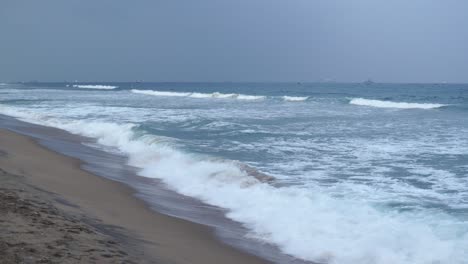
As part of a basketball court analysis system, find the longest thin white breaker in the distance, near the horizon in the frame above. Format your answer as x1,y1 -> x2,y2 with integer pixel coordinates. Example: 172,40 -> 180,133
131,89 -> 266,100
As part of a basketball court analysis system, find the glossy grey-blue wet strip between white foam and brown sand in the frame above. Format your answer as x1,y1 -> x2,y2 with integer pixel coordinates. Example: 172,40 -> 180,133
0,115 -> 300,264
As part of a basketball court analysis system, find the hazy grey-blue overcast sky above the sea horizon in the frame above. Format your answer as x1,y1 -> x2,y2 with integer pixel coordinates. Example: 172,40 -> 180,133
0,0 -> 468,83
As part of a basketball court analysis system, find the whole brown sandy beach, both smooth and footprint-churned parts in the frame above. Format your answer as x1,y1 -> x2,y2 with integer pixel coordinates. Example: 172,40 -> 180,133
0,130 -> 265,263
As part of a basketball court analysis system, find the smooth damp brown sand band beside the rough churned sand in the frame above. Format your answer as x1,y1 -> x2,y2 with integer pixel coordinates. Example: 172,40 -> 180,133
0,129 -> 267,263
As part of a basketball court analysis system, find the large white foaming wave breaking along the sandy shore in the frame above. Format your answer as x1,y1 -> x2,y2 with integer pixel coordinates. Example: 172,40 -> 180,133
0,107 -> 468,264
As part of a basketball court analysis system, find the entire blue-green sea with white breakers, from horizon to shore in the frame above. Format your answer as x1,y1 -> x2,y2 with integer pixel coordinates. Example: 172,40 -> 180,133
0,83 -> 468,264
